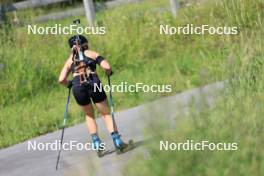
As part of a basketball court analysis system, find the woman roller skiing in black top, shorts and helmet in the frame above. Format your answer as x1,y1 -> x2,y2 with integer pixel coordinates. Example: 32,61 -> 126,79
59,35 -> 128,157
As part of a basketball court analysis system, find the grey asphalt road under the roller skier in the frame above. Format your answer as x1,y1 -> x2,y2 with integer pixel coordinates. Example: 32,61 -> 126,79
0,82 -> 224,176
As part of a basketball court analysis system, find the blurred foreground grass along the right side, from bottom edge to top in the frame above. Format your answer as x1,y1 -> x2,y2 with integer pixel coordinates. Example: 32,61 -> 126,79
124,0 -> 264,176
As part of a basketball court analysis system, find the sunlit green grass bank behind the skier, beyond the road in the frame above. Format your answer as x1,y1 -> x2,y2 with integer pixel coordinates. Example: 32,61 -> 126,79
0,0 -> 261,148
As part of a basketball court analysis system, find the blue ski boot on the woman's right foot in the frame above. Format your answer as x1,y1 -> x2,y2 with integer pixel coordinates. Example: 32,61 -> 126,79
111,132 -> 133,154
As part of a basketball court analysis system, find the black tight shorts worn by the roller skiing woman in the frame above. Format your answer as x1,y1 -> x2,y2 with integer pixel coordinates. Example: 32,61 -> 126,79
72,75 -> 107,106
